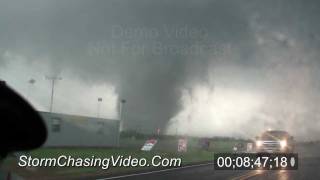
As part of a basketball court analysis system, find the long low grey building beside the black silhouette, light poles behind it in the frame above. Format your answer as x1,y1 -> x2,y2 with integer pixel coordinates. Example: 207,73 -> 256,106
39,112 -> 119,147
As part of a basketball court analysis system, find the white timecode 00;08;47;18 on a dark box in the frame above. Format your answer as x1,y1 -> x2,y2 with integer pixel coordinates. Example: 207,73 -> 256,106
214,153 -> 298,170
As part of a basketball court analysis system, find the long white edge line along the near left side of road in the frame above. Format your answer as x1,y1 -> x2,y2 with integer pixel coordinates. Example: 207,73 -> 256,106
96,163 -> 213,180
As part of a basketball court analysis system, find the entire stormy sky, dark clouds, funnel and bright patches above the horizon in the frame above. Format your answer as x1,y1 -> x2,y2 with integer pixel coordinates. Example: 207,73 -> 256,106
0,0 -> 320,139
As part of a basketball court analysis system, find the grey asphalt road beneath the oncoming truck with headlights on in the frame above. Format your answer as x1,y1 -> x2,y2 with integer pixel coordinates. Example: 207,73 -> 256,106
91,144 -> 320,180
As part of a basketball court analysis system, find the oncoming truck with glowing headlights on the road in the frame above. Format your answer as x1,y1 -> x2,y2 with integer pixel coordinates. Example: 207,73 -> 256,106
255,130 -> 294,153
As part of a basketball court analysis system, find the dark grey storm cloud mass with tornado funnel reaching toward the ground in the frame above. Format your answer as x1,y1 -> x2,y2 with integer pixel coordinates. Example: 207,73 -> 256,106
0,0 -> 320,138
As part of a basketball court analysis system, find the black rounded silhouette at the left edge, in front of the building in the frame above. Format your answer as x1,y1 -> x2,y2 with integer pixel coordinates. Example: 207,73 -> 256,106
0,80 -> 47,157
